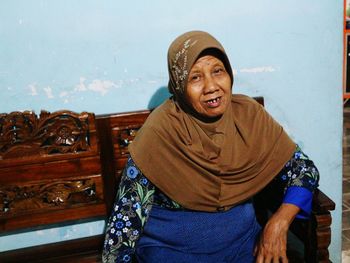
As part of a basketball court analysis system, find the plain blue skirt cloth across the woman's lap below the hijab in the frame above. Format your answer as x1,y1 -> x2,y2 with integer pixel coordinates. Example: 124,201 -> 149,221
136,202 -> 261,263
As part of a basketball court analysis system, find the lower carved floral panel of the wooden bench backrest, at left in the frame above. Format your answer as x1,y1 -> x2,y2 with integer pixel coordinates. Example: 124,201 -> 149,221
0,179 -> 97,214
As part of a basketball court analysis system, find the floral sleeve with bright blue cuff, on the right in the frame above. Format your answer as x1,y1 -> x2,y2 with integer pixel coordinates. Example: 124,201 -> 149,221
278,147 -> 319,218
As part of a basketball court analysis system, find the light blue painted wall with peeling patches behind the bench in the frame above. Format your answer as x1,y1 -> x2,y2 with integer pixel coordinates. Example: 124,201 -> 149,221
0,0 -> 343,262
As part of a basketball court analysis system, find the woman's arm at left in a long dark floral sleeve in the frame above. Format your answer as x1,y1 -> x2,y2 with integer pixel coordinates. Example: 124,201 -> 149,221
102,158 -> 155,263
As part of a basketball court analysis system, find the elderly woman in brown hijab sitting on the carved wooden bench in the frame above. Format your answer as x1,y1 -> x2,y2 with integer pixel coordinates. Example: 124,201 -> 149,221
103,31 -> 319,263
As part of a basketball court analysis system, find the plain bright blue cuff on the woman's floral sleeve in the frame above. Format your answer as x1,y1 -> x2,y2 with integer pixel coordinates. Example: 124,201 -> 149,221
283,186 -> 312,219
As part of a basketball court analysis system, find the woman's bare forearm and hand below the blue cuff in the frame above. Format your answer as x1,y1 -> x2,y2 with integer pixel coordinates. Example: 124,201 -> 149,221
254,204 -> 300,263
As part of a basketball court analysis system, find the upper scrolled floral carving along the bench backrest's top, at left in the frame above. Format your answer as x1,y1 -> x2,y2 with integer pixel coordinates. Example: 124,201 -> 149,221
0,111 -> 90,159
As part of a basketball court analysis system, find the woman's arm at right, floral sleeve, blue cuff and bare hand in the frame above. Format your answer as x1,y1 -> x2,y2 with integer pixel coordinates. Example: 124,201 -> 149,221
255,147 -> 319,263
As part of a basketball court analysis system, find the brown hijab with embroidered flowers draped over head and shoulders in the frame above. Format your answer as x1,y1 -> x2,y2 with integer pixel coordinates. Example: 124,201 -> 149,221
129,31 -> 295,211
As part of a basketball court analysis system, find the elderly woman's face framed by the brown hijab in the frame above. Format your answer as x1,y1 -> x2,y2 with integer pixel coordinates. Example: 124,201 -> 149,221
185,55 -> 231,118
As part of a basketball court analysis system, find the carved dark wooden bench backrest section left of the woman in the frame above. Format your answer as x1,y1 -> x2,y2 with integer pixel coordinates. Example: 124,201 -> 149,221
0,111 -> 106,231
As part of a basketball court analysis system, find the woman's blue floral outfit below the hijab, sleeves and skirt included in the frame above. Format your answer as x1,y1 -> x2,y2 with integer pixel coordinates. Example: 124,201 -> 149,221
102,147 -> 319,263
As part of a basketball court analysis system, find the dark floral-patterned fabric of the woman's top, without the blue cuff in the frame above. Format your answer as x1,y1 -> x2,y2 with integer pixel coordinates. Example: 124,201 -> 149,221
102,147 -> 319,263
